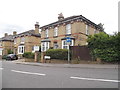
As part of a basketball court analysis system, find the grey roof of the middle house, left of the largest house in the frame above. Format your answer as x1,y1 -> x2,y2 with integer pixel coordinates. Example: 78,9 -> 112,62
14,30 -> 40,38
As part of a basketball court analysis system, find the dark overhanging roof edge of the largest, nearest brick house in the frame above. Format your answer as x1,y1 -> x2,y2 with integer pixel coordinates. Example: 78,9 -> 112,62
40,15 -> 104,30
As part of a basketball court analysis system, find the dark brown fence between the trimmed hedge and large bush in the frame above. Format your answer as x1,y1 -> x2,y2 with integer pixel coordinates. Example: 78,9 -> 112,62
70,46 -> 92,60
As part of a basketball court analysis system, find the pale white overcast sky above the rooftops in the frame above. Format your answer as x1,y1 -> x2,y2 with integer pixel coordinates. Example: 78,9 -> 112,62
0,0 -> 119,37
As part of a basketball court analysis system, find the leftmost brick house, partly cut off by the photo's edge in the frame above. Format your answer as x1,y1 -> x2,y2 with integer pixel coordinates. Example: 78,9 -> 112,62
0,31 -> 16,56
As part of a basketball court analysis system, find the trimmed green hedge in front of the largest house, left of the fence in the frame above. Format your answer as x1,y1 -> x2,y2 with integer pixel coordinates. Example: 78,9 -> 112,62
46,49 -> 68,60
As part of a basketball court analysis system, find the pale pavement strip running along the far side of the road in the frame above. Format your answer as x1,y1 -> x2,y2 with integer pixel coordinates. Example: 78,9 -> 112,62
12,59 -> 119,69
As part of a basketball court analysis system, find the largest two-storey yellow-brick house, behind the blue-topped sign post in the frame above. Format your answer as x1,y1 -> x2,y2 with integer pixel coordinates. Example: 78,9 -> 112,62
40,13 -> 103,52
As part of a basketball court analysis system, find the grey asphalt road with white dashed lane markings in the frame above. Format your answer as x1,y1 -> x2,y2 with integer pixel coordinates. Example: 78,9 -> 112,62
0,61 -> 119,88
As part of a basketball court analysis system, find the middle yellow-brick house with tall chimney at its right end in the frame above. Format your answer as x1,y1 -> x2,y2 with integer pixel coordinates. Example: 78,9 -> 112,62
14,22 -> 41,56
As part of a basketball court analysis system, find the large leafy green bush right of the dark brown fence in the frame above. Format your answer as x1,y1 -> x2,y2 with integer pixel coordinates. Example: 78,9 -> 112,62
87,32 -> 120,61
